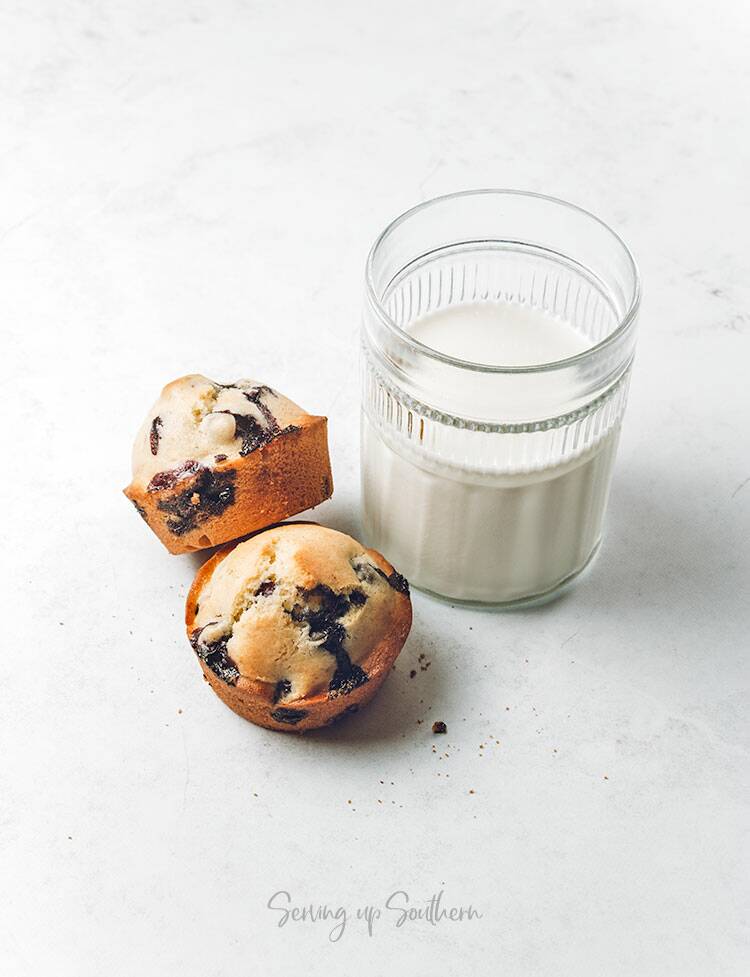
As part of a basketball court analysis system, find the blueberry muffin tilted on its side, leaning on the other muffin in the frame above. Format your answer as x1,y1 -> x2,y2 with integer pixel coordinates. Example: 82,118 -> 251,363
125,374 -> 333,553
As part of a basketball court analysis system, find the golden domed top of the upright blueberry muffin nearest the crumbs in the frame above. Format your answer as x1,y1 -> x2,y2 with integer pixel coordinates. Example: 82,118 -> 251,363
191,523 -> 408,703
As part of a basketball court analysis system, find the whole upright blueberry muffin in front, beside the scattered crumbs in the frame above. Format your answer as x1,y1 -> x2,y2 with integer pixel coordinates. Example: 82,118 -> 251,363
186,523 -> 411,732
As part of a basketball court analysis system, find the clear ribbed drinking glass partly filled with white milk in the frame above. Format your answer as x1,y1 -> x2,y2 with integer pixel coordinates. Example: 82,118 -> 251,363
362,190 -> 639,606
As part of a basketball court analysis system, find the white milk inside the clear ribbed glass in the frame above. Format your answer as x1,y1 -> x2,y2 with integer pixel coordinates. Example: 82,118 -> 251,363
362,302 -> 619,603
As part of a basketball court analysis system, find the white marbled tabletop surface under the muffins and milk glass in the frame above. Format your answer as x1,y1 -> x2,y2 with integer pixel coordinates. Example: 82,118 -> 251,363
0,0 -> 750,977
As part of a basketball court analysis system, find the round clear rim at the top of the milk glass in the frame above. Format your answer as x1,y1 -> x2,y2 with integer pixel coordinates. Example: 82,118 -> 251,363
365,187 -> 641,374
